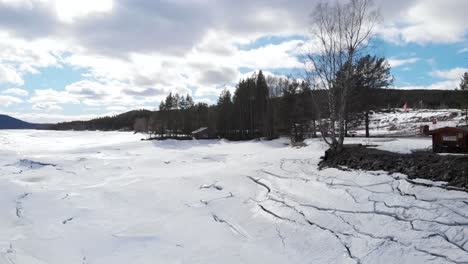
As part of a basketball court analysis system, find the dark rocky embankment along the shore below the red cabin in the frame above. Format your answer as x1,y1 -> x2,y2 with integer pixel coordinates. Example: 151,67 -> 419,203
320,145 -> 468,191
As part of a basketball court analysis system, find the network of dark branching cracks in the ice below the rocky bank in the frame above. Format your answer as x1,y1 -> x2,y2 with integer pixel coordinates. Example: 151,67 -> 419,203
250,159 -> 468,263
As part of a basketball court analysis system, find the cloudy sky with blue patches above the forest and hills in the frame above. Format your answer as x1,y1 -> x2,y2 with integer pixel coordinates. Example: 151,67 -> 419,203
0,0 -> 468,122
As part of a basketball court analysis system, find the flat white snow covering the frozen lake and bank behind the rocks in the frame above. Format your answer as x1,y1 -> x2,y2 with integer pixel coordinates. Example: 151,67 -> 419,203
0,131 -> 468,264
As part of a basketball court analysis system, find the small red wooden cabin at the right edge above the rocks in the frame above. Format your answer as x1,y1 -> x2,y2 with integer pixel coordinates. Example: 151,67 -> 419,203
427,127 -> 468,153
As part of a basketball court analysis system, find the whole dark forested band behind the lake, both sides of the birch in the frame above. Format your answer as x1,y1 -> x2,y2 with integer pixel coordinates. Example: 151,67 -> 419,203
47,74 -> 468,141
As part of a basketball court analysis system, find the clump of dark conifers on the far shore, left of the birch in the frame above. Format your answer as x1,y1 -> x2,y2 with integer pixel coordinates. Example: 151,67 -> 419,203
148,71 -> 315,140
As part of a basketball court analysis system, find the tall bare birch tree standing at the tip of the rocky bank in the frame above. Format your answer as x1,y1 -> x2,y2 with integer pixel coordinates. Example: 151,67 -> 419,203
306,0 -> 380,152
